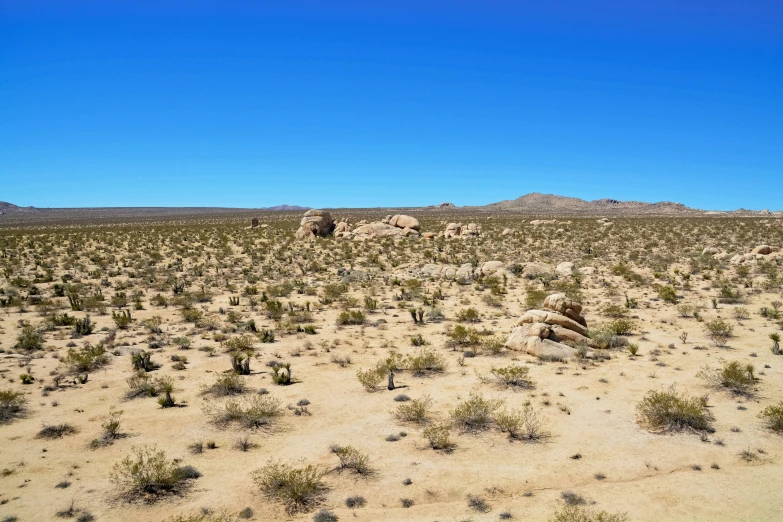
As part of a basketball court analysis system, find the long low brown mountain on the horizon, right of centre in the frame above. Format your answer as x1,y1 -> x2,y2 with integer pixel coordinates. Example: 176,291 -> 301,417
481,192 -> 704,214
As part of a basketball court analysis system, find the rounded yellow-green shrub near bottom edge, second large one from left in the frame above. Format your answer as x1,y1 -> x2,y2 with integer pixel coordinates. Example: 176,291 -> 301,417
252,462 -> 327,514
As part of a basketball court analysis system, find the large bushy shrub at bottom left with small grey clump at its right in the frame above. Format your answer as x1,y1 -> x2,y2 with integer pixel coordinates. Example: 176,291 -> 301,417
110,446 -> 198,499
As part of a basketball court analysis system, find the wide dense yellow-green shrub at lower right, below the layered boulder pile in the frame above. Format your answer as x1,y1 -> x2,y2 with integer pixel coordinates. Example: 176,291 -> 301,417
636,387 -> 715,433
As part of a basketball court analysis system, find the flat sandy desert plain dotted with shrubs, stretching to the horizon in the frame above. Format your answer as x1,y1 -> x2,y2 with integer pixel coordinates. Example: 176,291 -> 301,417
0,208 -> 783,522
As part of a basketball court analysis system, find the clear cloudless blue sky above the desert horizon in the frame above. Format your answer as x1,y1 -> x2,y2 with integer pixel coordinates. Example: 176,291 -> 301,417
0,0 -> 783,210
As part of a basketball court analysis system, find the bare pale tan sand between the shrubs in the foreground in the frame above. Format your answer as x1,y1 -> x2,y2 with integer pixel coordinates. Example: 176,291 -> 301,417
0,213 -> 783,521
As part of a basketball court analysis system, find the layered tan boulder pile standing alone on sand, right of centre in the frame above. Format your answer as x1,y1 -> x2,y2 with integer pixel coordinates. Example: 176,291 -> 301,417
506,294 -> 596,360
